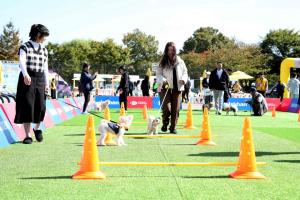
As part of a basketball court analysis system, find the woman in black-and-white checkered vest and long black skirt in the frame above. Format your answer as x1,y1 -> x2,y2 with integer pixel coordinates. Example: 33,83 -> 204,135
14,24 -> 49,144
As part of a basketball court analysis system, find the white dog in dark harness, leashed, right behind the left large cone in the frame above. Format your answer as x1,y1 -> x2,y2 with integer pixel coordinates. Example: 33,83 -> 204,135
97,115 -> 133,146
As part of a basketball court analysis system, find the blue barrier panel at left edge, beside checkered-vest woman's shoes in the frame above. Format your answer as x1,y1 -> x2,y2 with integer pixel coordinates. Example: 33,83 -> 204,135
0,109 -> 19,148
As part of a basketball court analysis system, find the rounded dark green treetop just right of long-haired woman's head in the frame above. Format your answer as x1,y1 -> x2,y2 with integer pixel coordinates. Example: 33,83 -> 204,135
181,27 -> 233,53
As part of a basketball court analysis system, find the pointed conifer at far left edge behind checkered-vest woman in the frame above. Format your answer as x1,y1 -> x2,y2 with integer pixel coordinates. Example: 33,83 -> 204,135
0,22 -> 21,60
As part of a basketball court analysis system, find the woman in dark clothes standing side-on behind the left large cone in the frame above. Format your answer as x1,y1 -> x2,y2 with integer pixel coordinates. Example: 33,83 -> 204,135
80,63 -> 97,114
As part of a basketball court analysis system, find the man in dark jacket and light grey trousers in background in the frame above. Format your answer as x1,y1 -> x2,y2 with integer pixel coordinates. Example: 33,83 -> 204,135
208,61 -> 229,115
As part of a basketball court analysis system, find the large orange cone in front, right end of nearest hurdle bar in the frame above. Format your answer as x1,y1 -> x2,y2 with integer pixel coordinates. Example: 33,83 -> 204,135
230,117 -> 265,179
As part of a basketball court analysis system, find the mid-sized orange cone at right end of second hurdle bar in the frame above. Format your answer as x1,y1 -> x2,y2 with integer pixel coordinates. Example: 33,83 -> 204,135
196,108 -> 216,146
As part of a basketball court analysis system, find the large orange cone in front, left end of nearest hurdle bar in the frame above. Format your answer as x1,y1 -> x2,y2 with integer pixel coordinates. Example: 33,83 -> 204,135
72,116 -> 106,179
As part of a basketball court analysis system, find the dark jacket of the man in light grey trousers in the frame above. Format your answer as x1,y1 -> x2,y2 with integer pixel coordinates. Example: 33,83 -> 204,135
208,69 -> 229,90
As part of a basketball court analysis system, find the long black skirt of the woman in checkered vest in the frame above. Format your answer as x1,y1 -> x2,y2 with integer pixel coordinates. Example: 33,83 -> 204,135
14,71 -> 46,124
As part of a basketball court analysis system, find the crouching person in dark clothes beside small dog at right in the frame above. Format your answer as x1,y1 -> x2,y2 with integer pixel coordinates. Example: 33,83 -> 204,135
246,87 -> 268,116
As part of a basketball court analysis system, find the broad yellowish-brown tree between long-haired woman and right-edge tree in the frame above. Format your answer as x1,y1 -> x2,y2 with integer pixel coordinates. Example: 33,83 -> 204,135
181,43 -> 270,83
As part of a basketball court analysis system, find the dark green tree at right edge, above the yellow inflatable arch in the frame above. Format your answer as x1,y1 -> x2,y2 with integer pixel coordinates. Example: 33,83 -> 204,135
260,29 -> 300,74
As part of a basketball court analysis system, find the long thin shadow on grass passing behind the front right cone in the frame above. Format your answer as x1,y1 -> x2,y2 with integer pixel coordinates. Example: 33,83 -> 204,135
188,151 -> 300,157
